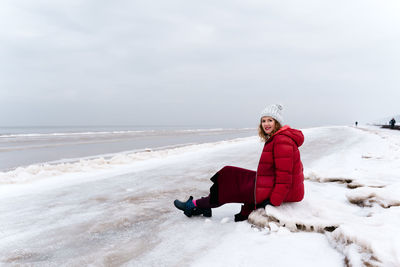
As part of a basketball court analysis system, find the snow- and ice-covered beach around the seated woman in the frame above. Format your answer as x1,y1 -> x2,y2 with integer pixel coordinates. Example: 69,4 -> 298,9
0,126 -> 400,266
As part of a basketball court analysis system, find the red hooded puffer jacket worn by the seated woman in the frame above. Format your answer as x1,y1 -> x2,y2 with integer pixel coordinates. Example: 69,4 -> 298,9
254,126 -> 304,206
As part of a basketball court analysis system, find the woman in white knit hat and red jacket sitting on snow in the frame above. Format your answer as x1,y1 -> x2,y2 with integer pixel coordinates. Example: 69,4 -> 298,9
174,104 -> 304,221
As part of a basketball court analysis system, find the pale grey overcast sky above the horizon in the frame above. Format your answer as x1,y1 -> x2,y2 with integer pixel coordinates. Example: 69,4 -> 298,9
0,0 -> 400,130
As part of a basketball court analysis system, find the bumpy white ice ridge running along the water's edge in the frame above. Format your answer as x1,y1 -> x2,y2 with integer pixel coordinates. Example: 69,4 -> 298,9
0,136 -> 257,193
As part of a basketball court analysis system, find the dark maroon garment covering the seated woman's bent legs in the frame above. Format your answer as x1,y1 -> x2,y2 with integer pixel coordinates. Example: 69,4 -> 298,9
196,166 -> 256,215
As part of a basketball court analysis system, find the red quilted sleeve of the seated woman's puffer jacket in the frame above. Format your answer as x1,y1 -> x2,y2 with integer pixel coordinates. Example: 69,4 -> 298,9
270,136 -> 295,206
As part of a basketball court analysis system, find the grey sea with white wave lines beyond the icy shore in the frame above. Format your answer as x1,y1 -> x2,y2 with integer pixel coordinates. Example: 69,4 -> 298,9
0,126 -> 257,172
